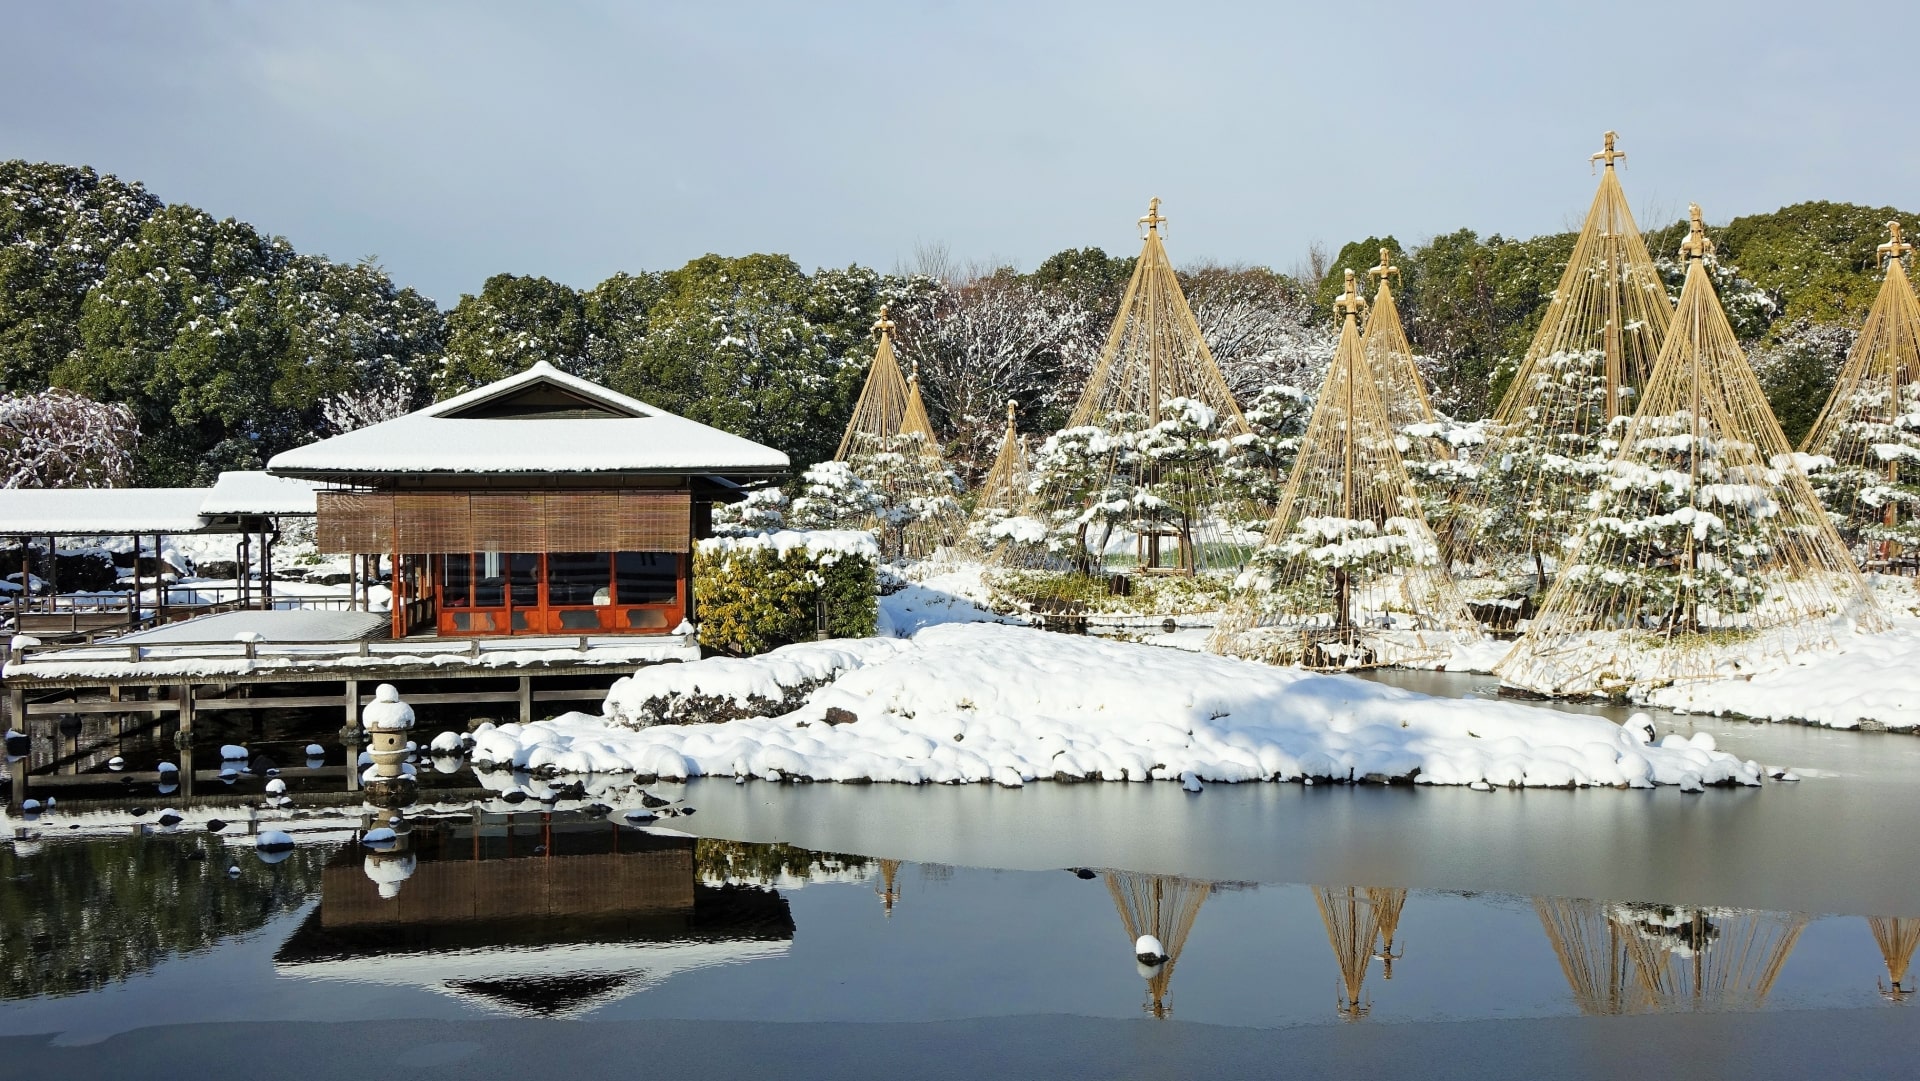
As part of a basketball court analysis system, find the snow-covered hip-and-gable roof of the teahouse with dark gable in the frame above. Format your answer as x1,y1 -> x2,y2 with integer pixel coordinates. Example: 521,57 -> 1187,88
267,361 -> 789,480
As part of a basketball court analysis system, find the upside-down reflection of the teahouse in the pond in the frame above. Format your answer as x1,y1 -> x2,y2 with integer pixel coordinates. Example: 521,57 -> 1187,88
275,814 -> 793,1018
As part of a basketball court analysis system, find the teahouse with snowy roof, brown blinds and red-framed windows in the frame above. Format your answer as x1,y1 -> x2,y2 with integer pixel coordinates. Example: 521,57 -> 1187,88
267,363 -> 787,637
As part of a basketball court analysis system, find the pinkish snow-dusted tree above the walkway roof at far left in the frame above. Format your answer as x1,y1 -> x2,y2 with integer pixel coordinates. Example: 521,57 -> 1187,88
0,388 -> 140,488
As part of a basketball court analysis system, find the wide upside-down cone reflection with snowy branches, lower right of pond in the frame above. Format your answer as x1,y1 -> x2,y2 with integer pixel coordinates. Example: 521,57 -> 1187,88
1615,904 -> 1807,1010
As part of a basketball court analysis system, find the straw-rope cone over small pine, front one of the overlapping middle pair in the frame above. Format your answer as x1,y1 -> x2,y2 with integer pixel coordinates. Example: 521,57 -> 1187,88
1212,271 -> 1480,668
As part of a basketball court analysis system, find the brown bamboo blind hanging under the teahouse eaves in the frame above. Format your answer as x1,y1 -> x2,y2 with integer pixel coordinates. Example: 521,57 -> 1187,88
315,492 -> 693,553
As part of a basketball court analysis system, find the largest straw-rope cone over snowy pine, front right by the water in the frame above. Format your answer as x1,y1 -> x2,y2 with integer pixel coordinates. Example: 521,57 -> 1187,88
1494,205 -> 1889,695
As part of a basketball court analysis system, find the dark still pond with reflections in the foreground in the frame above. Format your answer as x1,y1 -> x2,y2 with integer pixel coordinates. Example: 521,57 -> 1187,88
0,674 -> 1920,1075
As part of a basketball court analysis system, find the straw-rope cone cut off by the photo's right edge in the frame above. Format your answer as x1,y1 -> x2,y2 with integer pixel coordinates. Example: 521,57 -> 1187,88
1801,221 -> 1920,563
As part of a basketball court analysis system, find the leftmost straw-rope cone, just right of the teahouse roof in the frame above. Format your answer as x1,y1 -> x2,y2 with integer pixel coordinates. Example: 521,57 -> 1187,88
833,307 -> 964,559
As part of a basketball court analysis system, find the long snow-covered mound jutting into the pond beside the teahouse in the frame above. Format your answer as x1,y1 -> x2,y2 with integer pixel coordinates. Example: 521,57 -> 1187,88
474,624 -> 1763,787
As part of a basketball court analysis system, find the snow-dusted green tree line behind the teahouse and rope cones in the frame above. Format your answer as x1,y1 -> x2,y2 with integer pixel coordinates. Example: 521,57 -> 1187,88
0,161 -> 1914,484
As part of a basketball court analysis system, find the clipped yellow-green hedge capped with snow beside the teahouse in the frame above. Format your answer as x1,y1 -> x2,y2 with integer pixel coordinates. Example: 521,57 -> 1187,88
693,534 -> 879,657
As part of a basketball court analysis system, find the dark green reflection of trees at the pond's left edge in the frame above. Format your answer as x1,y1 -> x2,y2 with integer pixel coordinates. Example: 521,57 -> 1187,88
0,833 -> 328,998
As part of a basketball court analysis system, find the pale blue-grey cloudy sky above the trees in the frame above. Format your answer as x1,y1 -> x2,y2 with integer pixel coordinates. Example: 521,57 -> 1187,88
0,0 -> 1920,305
